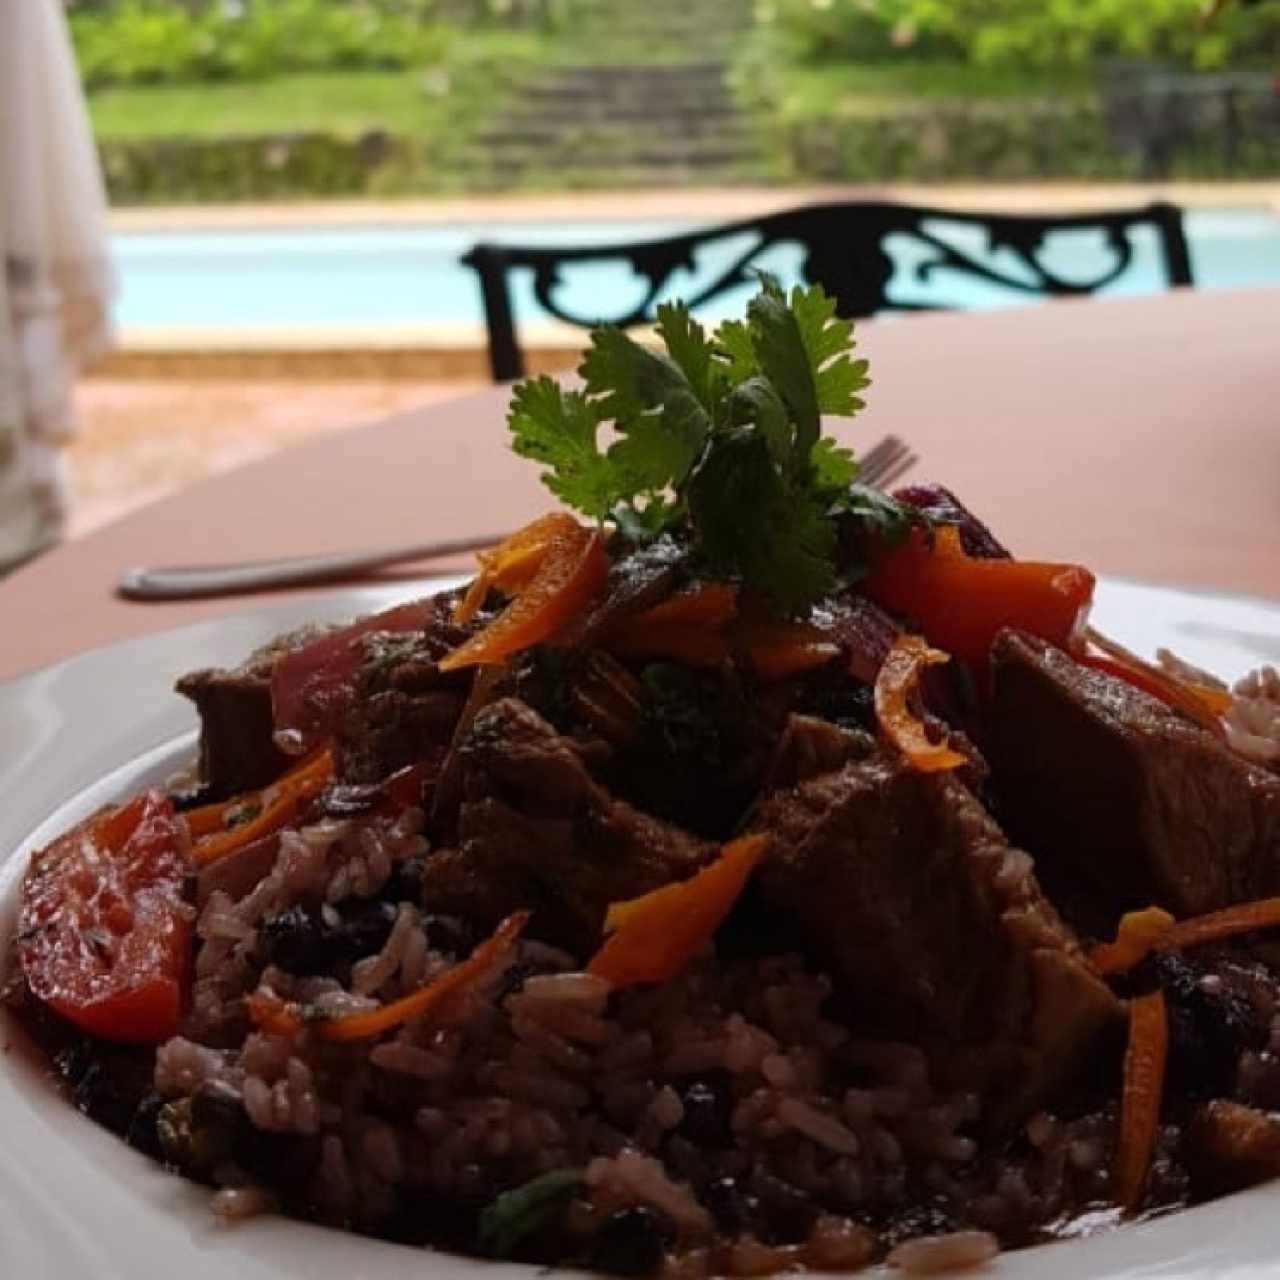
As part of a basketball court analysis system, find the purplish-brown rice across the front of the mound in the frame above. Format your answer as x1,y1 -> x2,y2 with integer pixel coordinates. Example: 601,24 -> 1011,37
140,798 -> 1141,1280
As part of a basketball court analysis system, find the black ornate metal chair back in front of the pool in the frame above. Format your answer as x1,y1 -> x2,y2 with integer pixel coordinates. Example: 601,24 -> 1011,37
462,201 -> 1193,381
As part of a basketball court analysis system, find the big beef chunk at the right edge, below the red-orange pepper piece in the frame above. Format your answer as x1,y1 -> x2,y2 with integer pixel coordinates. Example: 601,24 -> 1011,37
987,631 -> 1280,932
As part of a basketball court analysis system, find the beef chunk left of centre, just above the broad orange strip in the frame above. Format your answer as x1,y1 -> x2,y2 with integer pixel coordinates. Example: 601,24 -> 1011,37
422,698 -> 714,954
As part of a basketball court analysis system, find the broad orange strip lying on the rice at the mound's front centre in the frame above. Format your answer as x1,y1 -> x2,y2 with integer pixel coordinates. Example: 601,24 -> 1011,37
588,835 -> 769,987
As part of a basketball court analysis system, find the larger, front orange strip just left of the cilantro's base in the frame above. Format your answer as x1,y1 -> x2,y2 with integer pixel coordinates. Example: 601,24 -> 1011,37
440,524 -> 609,671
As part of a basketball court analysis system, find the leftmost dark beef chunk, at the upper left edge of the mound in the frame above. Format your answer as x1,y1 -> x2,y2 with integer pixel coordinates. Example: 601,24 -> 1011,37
177,627 -> 321,797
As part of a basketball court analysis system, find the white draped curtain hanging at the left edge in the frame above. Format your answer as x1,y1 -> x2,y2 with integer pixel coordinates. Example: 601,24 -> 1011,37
0,0 -> 114,571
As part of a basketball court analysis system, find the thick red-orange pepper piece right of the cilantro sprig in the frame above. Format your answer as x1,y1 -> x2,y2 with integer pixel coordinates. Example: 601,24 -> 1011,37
863,526 -> 1094,663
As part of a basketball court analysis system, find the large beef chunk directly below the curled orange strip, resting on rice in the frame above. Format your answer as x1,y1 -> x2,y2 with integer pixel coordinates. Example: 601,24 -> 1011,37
755,753 -> 1119,1115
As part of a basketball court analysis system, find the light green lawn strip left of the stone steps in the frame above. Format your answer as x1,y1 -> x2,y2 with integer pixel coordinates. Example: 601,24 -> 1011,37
88,32 -> 550,138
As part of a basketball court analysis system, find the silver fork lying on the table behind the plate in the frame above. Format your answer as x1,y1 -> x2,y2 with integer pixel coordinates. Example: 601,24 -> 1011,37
116,435 -> 918,600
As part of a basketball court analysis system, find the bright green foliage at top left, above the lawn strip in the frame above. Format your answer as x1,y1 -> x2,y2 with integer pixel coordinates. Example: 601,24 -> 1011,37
70,0 -> 448,88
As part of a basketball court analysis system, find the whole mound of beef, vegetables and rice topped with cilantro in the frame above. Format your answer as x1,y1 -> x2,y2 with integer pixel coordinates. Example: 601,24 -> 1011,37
9,280 -> 1280,1277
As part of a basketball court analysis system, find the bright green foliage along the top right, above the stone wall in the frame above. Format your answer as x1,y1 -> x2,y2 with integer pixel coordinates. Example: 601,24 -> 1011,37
764,0 -> 1280,68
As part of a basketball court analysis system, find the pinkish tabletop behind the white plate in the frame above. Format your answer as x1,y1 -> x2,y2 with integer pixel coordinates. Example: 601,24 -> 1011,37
0,289 -> 1280,678
